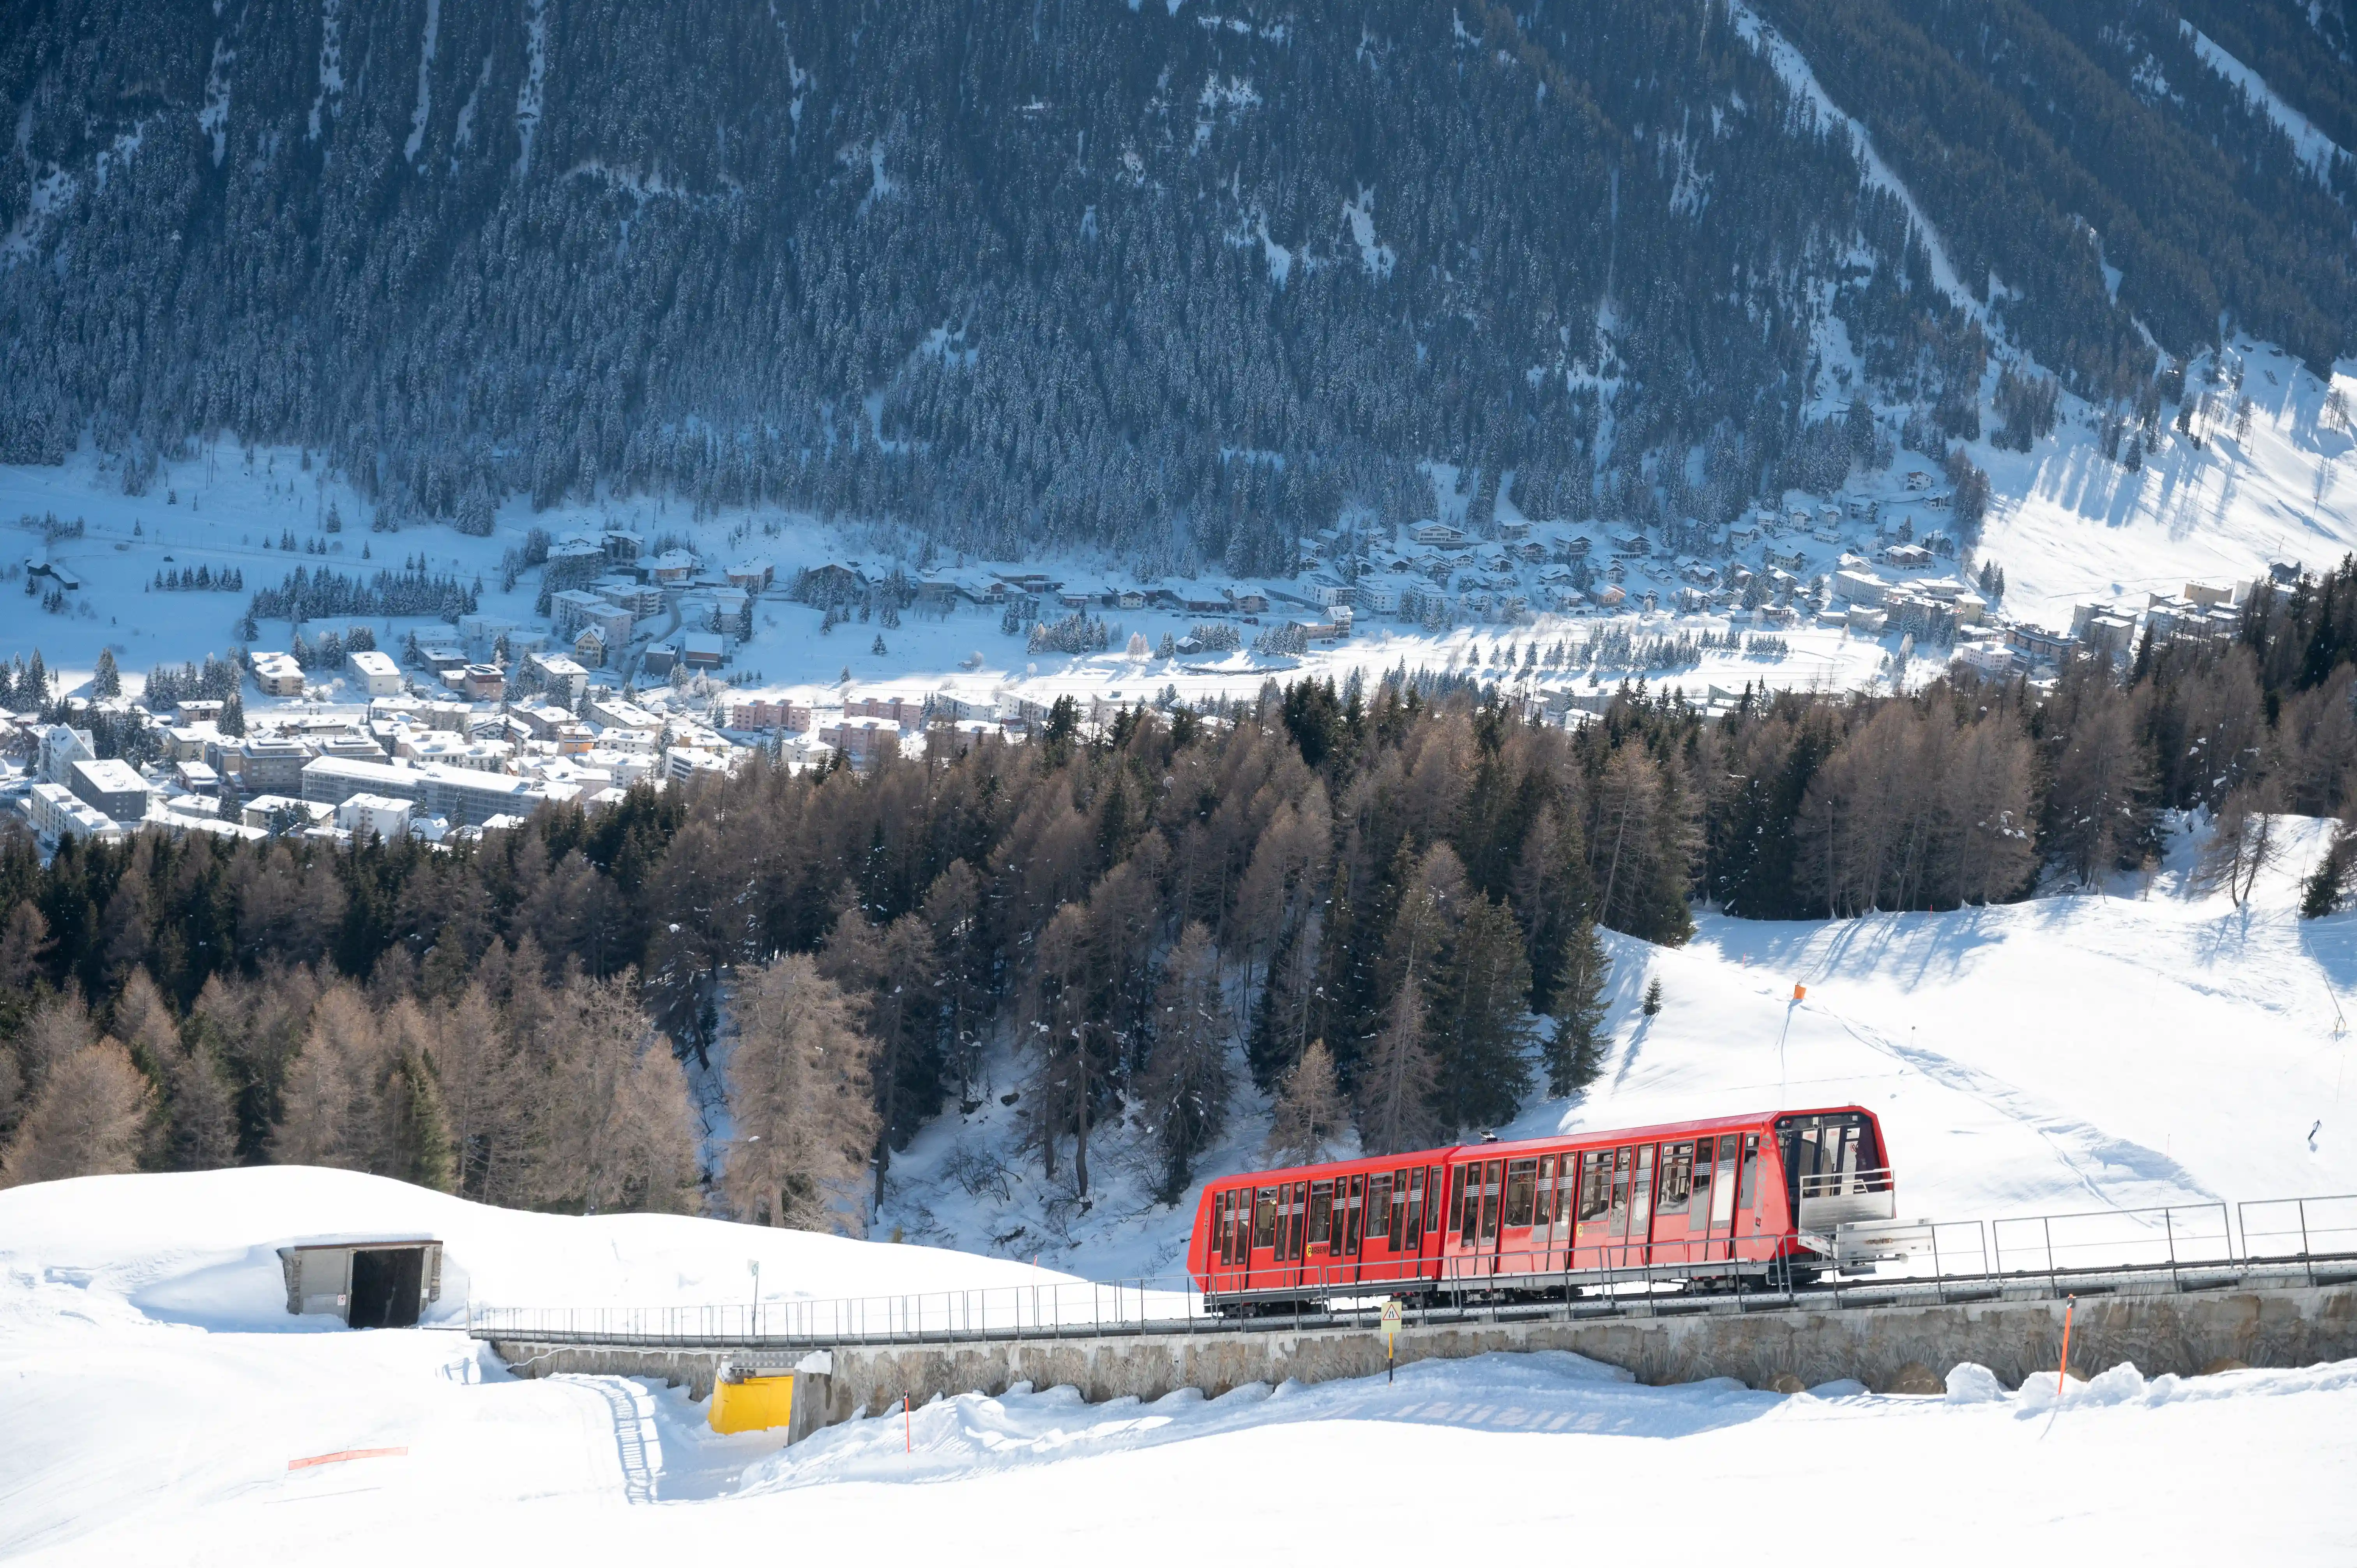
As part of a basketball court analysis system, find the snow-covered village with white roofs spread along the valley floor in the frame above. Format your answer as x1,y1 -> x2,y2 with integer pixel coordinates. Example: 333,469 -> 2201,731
0,391 -> 2329,844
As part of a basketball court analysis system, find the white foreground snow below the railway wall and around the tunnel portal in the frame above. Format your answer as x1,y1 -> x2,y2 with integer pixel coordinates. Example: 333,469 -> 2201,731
0,1169 -> 2357,1566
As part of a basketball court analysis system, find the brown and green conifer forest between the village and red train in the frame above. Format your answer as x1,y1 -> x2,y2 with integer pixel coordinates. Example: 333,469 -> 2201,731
14,561 -> 2357,1229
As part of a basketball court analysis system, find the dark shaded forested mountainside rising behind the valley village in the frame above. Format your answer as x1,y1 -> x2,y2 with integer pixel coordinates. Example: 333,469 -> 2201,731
0,0 -> 2357,570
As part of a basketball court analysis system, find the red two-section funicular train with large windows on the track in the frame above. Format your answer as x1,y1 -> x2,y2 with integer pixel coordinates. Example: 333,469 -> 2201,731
1188,1106 -> 1898,1313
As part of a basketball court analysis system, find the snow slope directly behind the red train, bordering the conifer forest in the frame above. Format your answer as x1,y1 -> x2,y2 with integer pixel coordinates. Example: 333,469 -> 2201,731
884,818 -> 2357,1278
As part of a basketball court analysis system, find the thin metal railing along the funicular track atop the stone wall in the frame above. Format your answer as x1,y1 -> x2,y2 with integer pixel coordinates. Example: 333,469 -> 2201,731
467,1195 -> 2357,1349
